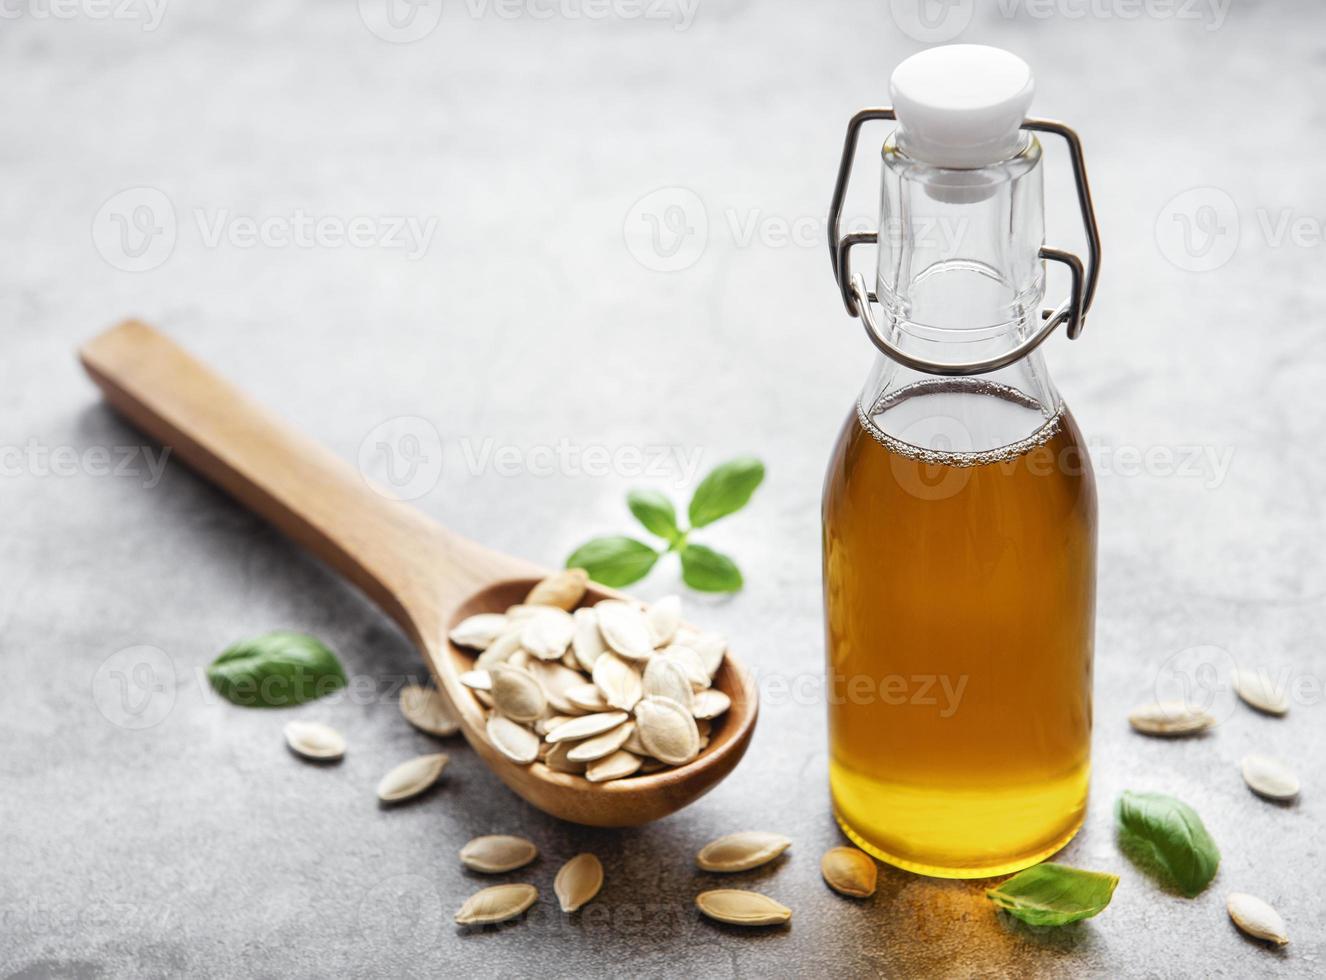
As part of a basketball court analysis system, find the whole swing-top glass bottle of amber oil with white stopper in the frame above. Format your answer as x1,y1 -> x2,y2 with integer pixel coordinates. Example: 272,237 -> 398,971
823,45 -> 1098,878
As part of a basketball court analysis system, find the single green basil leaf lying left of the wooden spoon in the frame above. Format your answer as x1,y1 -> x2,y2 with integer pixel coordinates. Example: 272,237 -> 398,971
207,630 -> 346,708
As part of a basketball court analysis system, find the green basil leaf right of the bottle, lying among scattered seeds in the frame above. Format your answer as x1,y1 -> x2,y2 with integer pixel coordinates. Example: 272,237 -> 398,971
1114,790 -> 1220,898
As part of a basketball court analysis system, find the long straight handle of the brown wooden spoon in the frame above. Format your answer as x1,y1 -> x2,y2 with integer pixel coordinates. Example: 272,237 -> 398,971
80,321 -> 480,646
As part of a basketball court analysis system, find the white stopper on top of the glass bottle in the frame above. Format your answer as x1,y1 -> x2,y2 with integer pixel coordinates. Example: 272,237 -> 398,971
888,44 -> 1036,170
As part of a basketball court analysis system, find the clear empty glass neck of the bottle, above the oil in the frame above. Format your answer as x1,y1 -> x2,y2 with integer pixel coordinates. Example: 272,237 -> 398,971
861,134 -> 1059,454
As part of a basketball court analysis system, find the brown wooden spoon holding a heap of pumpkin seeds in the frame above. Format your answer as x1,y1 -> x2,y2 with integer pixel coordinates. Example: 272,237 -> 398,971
80,321 -> 757,826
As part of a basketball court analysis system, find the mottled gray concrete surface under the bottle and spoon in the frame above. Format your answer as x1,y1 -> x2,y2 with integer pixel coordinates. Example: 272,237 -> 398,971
0,0 -> 1326,977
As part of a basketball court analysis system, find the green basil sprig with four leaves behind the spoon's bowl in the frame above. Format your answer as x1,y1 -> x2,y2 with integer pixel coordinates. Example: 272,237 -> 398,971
566,456 -> 764,591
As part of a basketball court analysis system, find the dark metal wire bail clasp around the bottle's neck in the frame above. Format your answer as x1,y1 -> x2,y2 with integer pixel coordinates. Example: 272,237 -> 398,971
829,107 -> 1101,375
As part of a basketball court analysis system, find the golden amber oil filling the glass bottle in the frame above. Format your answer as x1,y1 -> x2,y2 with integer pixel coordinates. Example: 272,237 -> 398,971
823,379 -> 1095,878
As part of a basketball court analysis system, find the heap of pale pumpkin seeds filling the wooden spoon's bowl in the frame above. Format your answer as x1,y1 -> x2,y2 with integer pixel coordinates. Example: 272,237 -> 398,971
450,569 -> 731,782
